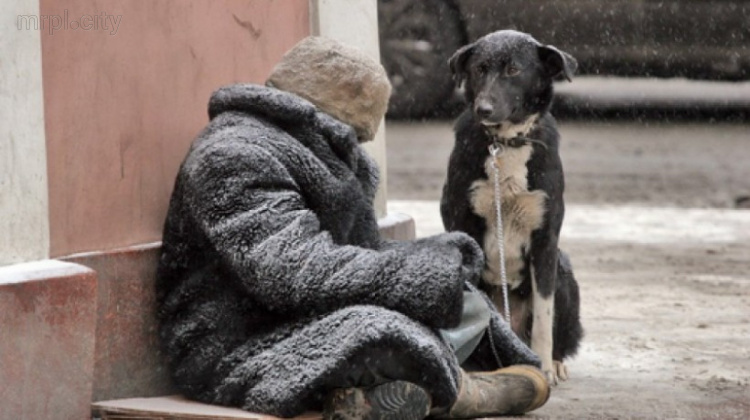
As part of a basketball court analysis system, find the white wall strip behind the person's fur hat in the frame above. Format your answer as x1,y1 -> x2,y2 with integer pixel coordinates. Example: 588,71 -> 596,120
311,0 -> 388,217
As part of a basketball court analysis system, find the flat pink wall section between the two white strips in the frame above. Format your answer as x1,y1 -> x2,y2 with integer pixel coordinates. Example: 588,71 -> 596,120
40,0 -> 310,257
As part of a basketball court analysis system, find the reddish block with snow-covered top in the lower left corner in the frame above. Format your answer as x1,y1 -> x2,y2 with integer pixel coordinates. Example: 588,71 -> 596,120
0,260 -> 97,420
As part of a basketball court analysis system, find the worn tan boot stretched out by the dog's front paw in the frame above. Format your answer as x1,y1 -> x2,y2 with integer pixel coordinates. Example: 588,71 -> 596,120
438,365 -> 550,419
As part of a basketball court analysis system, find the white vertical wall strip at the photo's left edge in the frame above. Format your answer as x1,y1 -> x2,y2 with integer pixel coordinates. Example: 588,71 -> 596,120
0,0 -> 49,266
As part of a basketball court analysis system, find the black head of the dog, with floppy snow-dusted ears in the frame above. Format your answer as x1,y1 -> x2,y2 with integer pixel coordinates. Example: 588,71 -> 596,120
448,30 -> 578,126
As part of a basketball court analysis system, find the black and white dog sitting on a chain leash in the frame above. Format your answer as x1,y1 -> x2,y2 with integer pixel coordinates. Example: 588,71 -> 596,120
440,30 -> 583,383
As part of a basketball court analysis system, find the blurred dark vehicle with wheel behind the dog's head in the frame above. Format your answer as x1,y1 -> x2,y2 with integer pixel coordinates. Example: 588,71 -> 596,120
378,0 -> 750,119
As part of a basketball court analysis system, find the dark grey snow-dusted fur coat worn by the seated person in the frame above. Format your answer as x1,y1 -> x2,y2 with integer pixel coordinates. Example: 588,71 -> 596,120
157,85 -> 538,417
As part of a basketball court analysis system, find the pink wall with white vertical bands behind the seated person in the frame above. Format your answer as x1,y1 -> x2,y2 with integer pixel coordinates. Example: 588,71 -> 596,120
0,0 -> 394,264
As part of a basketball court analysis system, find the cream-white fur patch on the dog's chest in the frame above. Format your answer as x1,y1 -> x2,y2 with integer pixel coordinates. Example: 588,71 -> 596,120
469,145 -> 546,288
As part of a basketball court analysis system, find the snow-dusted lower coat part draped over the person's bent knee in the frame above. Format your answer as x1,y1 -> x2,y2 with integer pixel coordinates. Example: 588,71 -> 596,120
209,306 -> 460,417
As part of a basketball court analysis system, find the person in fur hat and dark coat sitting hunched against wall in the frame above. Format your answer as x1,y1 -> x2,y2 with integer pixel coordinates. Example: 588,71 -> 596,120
156,37 -> 549,420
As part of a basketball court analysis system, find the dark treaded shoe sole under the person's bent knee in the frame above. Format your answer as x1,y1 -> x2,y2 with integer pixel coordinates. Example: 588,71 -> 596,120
323,381 -> 431,420
